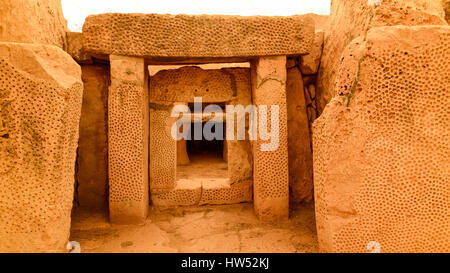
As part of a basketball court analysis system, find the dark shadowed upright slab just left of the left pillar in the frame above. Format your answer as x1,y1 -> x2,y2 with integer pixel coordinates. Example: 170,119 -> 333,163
77,65 -> 110,209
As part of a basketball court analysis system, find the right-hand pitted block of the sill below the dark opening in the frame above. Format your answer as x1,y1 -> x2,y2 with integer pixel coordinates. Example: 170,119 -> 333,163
199,179 -> 253,205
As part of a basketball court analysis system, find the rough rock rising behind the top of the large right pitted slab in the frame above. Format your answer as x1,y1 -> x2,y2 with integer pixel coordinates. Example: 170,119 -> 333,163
317,0 -> 447,113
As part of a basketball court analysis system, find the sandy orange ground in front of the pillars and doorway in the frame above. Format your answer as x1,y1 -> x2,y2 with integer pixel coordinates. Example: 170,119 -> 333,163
71,202 -> 318,253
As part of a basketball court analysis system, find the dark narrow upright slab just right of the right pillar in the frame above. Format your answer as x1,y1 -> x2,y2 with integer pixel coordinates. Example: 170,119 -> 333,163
286,60 -> 313,203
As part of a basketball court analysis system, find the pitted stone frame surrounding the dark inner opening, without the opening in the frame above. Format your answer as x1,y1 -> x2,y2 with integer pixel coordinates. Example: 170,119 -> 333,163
150,67 -> 253,206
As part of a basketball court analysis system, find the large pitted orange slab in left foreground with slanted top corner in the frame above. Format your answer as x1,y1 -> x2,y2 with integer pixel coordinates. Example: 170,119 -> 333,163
0,43 -> 83,252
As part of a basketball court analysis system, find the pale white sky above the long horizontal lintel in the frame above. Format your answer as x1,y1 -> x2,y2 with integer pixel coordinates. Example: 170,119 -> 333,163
61,0 -> 331,31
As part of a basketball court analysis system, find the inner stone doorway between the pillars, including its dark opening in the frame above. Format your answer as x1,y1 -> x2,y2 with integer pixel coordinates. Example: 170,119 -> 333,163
149,64 -> 253,206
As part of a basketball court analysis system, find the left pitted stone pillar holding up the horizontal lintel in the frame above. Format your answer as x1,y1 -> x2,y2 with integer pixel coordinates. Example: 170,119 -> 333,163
108,55 -> 149,224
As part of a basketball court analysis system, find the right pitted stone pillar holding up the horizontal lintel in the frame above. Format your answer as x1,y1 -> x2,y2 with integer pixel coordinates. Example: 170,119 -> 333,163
252,56 -> 289,221
